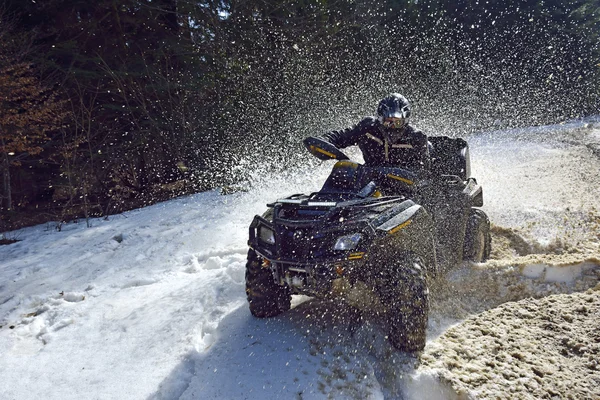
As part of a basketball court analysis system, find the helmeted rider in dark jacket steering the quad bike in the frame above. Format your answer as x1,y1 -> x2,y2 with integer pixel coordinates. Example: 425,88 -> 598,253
304,93 -> 430,172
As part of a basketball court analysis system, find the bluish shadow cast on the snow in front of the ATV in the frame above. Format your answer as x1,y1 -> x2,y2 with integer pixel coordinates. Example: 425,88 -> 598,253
150,299 -> 415,400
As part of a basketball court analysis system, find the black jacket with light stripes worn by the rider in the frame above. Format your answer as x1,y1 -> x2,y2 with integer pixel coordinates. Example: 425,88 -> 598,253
321,117 -> 430,171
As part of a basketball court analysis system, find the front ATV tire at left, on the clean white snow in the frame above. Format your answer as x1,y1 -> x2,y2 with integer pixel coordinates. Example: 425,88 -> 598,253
246,249 -> 292,318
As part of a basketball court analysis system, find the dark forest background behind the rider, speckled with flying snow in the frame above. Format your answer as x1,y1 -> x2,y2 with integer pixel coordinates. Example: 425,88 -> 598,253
0,0 -> 600,231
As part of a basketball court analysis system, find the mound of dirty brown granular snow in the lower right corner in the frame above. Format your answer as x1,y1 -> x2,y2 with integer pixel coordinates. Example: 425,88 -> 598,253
407,285 -> 600,399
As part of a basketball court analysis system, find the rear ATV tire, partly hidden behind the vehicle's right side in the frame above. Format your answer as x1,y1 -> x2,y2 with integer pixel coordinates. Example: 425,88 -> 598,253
463,208 -> 492,263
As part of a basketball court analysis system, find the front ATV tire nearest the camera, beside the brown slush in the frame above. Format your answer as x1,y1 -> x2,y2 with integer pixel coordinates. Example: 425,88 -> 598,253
376,254 -> 429,352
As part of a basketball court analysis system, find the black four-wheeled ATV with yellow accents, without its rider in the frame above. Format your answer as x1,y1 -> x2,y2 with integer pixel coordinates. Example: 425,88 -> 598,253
246,136 -> 491,351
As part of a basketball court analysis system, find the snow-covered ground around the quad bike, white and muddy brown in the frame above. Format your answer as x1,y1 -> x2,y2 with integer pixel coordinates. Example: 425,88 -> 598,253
0,121 -> 600,400
